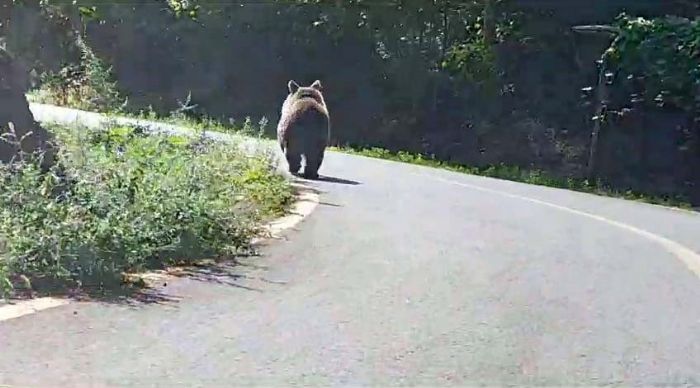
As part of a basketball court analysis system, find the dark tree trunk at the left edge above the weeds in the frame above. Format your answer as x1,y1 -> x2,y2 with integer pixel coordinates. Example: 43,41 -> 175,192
0,49 -> 55,169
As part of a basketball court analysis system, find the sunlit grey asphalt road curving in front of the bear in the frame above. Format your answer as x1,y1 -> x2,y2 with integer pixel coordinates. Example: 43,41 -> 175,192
0,123 -> 700,387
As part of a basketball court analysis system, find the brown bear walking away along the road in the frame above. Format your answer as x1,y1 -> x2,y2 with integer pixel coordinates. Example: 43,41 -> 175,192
277,80 -> 331,179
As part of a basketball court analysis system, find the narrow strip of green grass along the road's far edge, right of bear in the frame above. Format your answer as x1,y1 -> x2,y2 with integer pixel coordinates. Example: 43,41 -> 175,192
331,147 -> 691,209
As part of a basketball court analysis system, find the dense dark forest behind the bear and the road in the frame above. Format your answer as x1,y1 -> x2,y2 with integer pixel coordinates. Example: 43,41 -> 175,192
0,0 -> 700,206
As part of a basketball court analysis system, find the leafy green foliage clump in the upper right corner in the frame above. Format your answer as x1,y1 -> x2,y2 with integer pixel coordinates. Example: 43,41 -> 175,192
604,14 -> 700,113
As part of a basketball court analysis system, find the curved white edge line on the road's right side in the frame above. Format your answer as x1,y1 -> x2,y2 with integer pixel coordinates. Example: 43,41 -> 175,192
419,174 -> 700,278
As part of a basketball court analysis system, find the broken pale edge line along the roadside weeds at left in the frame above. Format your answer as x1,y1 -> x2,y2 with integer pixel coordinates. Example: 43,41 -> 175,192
0,186 -> 320,322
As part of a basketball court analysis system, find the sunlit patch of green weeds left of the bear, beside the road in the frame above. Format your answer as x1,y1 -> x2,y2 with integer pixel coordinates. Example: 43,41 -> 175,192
0,123 -> 294,296
